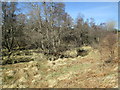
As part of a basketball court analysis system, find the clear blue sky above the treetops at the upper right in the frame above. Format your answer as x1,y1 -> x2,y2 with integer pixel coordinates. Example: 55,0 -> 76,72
65,2 -> 118,24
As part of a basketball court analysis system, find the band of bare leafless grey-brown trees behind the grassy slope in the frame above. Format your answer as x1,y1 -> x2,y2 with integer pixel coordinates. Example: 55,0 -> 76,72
2,2 -> 118,62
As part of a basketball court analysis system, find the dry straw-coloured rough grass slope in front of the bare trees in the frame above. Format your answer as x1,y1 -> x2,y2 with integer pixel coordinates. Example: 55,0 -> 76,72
0,43 -> 118,88
